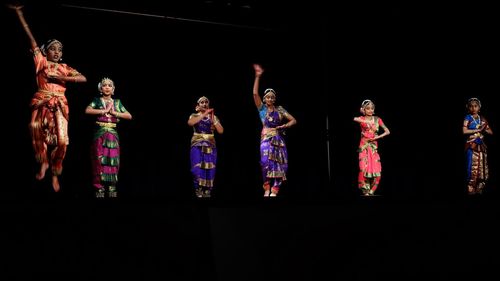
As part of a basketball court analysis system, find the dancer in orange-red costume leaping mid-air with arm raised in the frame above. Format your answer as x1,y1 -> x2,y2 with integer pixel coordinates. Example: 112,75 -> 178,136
8,5 -> 87,192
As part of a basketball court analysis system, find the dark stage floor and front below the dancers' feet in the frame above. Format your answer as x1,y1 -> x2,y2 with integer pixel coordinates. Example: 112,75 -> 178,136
0,194 -> 500,281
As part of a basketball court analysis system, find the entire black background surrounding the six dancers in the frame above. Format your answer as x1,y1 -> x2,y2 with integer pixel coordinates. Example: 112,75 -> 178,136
0,0 -> 499,280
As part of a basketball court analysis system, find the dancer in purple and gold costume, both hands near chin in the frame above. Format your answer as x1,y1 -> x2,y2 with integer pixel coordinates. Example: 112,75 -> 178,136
188,96 -> 224,198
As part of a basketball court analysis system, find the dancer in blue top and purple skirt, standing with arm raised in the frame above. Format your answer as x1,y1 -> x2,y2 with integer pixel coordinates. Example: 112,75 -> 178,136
253,64 -> 297,197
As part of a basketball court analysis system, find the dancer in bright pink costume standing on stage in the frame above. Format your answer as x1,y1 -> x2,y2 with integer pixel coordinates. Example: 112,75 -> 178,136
354,100 -> 390,196
